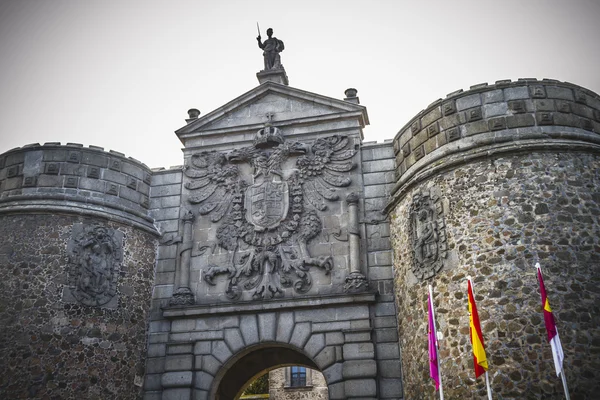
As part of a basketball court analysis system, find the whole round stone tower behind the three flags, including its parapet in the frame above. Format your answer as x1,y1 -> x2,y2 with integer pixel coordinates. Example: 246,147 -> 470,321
387,79 -> 600,399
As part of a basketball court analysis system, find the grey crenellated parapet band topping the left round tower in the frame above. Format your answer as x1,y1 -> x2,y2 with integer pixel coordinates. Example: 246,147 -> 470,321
0,142 -> 156,233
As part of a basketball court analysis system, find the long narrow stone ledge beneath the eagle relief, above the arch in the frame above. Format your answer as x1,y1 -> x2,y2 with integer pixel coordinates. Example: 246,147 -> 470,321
163,292 -> 376,318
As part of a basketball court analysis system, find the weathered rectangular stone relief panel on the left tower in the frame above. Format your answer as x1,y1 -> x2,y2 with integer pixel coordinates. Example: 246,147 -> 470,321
63,224 -> 123,308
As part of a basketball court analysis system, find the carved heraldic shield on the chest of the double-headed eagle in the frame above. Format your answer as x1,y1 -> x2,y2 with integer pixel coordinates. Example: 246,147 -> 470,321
245,180 -> 289,231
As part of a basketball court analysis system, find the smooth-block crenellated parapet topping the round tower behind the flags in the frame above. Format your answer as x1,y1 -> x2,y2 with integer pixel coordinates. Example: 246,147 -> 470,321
388,79 -> 600,209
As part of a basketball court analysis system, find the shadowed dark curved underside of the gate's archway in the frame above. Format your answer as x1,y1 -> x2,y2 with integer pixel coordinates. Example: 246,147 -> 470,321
209,343 -> 319,400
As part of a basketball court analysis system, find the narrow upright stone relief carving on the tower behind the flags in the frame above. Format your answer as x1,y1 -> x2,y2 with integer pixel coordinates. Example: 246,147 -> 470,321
409,190 -> 447,280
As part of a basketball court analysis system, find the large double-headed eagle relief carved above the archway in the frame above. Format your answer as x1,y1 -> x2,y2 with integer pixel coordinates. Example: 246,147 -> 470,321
184,124 -> 356,300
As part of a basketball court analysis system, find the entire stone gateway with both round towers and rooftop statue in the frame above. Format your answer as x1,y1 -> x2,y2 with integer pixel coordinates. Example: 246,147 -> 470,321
0,30 -> 600,400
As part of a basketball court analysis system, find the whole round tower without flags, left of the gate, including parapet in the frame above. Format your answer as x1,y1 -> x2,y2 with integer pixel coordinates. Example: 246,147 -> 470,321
0,143 -> 157,399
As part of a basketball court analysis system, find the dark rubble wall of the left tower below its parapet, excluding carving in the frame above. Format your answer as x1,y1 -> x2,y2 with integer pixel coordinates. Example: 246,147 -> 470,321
0,214 -> 156,399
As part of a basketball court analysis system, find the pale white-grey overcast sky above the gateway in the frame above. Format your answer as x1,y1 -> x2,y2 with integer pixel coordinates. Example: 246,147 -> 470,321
0,0 -> 600,167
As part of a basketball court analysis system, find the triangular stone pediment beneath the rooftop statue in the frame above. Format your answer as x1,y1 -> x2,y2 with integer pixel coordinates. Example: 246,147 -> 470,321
175,82 -> 369,140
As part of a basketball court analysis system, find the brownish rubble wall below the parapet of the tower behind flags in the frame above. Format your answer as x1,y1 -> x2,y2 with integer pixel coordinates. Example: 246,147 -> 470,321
391,152 -> 600,399
